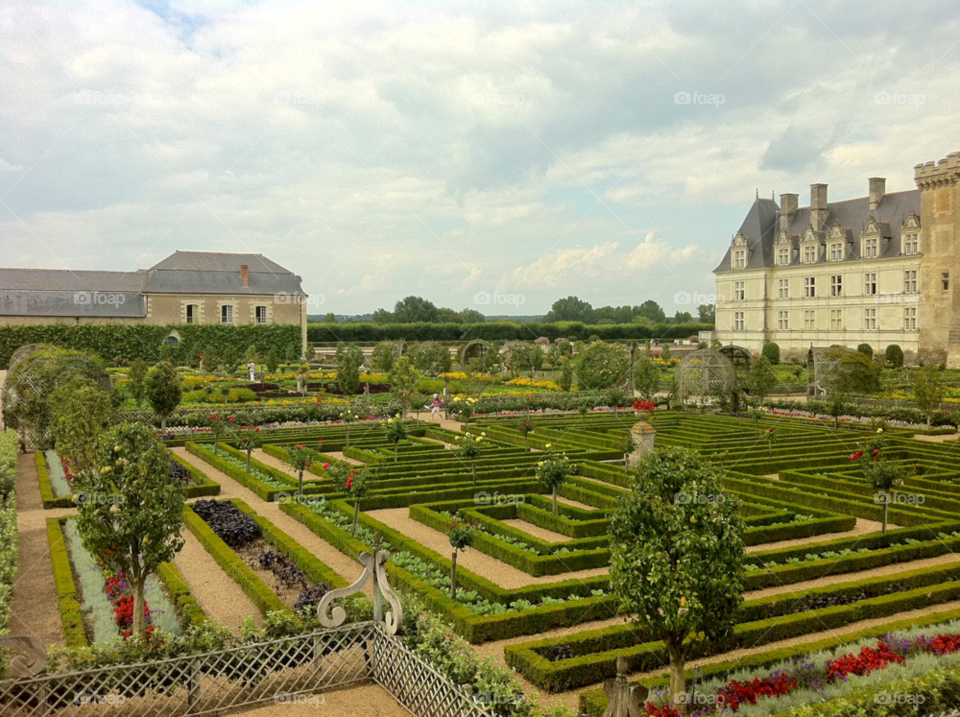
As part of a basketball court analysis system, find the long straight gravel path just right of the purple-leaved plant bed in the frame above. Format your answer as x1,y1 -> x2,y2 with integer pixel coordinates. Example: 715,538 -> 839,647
172,448 -> 370,595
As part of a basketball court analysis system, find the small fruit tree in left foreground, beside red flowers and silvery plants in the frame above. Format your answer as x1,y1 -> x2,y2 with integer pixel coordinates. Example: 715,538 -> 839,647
77,423 -> 184,635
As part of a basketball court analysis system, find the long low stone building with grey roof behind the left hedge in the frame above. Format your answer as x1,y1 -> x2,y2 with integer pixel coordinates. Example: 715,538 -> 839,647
0,251 -> 307,346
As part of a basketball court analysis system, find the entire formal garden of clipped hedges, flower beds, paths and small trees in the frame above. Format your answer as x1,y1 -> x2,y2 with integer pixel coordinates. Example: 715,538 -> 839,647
0,332 -> 960,717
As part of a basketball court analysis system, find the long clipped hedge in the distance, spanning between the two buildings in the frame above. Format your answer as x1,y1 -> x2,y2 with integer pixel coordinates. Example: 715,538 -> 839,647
307,321 -> 713,343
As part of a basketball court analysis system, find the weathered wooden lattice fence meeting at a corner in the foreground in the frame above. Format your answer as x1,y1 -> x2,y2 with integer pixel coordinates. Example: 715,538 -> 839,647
0,621 -> 492,717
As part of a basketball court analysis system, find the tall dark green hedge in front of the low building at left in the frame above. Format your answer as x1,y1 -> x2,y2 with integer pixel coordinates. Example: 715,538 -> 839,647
0,324 -> 300,369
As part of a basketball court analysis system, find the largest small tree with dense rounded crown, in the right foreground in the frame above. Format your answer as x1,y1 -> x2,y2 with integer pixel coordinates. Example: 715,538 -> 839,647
610,447 -> 744,709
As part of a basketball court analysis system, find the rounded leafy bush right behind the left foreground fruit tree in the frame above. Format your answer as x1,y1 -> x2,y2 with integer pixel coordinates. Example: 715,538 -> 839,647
51,376 -> 116,473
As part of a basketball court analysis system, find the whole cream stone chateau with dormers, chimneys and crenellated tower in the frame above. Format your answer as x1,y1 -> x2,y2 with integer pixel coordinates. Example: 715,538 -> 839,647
713,152 -> 960,367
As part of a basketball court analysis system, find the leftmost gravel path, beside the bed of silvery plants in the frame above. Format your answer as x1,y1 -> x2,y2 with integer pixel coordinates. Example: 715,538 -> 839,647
10,453 -> 76,647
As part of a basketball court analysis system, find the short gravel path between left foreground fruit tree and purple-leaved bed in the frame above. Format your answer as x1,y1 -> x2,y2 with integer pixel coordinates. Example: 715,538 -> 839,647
173,527 -> 263,630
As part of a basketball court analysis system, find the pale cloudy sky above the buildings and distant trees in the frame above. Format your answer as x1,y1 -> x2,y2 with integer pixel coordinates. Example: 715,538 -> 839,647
0,0 -> 960,315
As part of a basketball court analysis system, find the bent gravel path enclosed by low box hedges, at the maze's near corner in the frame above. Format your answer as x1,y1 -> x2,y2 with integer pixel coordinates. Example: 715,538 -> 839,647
364,508 -> 608,590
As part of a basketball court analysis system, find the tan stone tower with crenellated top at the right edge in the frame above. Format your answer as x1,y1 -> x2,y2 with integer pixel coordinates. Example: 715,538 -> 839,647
914,152 -> 960,368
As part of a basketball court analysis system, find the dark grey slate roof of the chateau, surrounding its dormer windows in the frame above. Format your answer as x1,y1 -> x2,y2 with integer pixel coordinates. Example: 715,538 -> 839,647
714,189 -> 920,273
